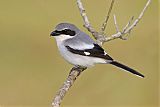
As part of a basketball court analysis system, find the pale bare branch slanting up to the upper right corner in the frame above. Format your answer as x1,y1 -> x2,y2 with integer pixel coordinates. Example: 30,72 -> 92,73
105,0 -> 151,42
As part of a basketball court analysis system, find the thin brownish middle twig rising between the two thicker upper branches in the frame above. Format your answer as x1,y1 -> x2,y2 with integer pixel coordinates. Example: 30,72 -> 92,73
101,0 -> 115,33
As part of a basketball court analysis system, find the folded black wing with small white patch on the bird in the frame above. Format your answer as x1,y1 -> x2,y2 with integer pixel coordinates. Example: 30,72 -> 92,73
66,44 -> 113,60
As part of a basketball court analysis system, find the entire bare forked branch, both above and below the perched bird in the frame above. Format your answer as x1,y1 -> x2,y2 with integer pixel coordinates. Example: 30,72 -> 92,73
52,0 -> 151,107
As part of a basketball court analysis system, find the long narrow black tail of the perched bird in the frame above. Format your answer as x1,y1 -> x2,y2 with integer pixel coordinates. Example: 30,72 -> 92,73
110,61 -> 144,78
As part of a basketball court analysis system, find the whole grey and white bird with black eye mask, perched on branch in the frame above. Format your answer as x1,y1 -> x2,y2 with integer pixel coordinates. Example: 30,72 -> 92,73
50,23 -> 144,78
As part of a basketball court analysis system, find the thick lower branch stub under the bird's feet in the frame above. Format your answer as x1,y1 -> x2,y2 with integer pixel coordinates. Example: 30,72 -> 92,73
52,67 -> 87,107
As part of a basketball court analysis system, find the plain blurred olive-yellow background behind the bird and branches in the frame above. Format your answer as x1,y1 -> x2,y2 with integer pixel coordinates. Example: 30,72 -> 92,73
0,0 -> 159,107
